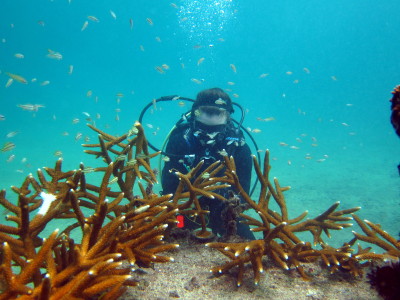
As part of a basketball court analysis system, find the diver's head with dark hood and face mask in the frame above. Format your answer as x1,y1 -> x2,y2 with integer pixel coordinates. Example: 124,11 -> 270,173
192,88 -> 233,126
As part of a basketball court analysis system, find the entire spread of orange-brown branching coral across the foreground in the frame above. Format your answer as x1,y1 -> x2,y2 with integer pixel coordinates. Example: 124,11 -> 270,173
0,123 -> 400,299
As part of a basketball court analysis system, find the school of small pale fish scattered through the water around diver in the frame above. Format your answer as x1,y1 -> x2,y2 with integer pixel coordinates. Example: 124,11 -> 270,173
0,0 -> 356,178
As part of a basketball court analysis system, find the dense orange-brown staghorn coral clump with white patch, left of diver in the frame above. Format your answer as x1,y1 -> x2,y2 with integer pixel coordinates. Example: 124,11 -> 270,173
0,124 -> 177,299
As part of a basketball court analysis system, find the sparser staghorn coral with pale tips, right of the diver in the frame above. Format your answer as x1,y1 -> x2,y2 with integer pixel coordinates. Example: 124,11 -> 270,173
206,151 -> 400,286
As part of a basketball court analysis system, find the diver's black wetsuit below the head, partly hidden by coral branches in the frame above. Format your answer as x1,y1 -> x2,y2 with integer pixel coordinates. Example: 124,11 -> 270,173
162,122 -> 254,239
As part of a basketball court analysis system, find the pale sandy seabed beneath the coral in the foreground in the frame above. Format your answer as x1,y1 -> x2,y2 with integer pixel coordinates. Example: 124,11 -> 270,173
121,243 -> 381,300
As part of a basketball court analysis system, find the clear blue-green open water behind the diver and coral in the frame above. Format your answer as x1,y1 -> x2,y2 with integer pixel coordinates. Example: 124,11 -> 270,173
0,0 -> 400,251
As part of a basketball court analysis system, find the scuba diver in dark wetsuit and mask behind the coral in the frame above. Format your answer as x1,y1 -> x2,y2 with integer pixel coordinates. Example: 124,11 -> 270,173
162,88 -> 254,239
